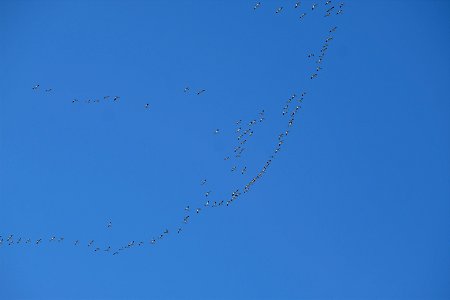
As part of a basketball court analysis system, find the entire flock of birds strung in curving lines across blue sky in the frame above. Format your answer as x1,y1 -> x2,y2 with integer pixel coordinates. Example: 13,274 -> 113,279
0,0 -> 344,255
